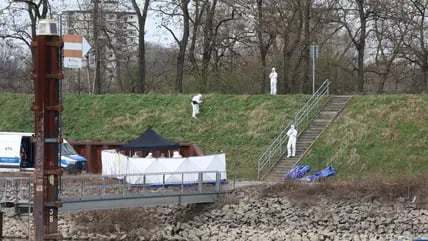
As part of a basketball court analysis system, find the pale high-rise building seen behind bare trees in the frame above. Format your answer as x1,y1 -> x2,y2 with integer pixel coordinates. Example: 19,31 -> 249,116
61,1 -> 138,93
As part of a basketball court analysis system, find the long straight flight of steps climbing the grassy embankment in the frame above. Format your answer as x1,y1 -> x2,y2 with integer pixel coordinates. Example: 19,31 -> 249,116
264,96 -> 351,182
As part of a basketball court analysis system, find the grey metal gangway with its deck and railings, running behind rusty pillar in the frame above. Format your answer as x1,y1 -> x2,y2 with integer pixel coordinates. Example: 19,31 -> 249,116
0,171 -> 229,211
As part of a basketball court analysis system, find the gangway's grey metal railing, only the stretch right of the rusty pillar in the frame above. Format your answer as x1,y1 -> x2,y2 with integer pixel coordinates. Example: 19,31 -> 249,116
59,171 -> 225,202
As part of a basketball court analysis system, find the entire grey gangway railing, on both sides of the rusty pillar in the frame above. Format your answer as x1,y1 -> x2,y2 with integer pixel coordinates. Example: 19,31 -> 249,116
0,171 -> 227,205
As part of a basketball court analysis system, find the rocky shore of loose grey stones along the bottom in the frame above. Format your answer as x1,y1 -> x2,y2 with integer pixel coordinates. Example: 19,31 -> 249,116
3,182 -> 428,241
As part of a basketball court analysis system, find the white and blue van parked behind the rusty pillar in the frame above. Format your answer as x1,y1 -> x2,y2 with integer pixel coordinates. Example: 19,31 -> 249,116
0,132 -> 87,172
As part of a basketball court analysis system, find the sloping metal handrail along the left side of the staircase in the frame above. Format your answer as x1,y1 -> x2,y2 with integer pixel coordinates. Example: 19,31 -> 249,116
257,79 -> 330,180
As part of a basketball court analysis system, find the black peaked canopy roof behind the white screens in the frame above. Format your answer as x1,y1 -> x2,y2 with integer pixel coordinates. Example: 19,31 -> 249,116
119,128 -> 180,151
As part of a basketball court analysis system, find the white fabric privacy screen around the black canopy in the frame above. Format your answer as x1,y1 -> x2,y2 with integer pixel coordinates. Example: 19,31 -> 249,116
101,150 -> 227,185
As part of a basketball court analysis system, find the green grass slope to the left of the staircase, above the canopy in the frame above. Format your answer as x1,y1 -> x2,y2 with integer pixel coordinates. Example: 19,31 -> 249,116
0,94 -> 309,179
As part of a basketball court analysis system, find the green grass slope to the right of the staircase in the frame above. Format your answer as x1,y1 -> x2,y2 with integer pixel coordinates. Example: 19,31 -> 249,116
302,95 -> 428,179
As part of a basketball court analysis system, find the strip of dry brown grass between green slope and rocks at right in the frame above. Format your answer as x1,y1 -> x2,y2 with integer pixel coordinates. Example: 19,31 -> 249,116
260,174 -> 428,208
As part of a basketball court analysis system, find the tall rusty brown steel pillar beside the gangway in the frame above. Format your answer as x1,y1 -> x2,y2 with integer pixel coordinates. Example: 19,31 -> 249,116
32,35 -> 64,241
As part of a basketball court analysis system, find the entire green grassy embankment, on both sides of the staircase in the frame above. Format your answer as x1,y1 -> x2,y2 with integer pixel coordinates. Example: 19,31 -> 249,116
0,94 -> 428,179
